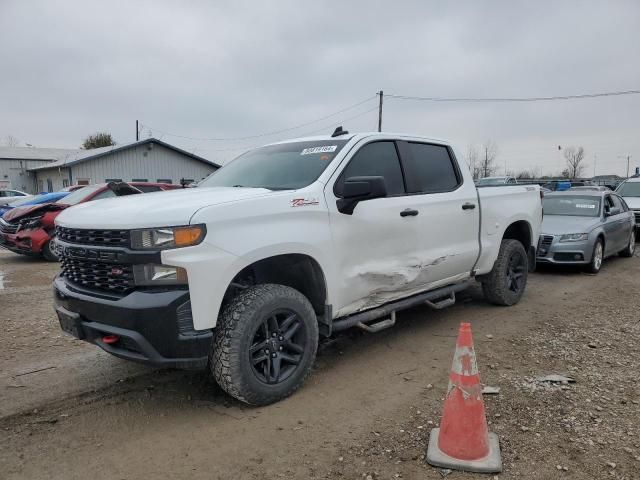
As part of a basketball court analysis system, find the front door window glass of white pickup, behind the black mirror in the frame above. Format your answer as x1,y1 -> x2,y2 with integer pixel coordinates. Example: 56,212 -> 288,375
334,142 -> 405,196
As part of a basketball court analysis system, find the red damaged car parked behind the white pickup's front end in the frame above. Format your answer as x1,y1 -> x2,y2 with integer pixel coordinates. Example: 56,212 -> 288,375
0,182 -> 180,261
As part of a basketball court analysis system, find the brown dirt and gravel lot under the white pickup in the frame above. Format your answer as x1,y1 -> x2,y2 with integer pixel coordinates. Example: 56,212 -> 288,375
0,248 -> 640,480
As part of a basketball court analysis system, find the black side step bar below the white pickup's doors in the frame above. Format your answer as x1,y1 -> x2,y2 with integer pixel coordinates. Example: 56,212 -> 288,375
332,282 -> 470,332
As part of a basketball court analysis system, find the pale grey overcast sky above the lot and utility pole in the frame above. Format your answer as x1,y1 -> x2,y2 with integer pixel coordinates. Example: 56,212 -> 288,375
0,0 -> 640,174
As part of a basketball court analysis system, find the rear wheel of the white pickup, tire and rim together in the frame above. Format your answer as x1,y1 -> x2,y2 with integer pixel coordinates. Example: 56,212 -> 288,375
482,240 -> 529,306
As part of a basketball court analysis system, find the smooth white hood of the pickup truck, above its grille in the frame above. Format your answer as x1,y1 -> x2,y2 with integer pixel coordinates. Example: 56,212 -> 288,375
56,187 -> 281,229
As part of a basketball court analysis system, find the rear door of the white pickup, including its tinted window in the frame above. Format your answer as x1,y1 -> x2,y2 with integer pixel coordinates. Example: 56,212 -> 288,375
398,141 -> 479,286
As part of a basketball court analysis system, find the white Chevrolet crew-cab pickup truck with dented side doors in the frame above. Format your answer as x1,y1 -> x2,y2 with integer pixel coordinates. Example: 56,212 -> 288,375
54,129 -> 542,405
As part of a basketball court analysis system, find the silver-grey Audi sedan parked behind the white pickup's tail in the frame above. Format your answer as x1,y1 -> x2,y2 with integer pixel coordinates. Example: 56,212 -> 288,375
537,190 -> 636,273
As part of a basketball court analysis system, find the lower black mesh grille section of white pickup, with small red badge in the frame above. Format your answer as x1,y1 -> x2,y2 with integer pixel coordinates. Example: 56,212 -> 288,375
60,256 -> 134,294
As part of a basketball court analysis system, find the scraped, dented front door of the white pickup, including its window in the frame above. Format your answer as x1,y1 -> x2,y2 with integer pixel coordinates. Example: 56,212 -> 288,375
325,141 -> 424,316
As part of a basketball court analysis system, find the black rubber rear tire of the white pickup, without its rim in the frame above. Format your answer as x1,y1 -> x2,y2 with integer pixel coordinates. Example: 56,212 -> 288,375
482,239 -> 529,306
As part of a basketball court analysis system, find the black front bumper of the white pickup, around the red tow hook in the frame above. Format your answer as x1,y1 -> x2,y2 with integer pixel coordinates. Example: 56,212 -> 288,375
53,276 -> 213,370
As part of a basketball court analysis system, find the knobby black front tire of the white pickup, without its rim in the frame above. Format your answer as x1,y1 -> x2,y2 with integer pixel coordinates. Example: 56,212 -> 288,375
209,284 -> 318,405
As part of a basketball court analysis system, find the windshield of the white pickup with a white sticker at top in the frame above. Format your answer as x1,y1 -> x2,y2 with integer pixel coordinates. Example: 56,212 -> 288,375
198,139 -> 349,190
